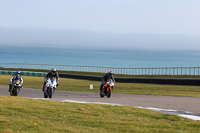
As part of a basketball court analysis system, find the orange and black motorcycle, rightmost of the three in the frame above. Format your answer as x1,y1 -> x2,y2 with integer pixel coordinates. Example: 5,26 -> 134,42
100,79 -> 115,98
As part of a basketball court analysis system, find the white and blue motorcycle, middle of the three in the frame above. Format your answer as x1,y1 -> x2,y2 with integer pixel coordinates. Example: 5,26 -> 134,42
44,77 -> 57,98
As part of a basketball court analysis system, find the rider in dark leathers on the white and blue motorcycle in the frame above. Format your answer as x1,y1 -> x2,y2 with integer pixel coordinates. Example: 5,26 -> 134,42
42,68 -> 59,91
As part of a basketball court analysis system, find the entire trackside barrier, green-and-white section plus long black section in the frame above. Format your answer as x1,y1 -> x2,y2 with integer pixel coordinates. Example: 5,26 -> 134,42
0,70 -> 200,86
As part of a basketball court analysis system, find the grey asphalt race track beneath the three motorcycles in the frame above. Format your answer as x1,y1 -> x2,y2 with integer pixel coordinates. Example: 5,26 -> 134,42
0,86 -> 200,120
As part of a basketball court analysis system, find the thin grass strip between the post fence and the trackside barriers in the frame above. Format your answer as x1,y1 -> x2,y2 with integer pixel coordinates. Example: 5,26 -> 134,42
0,68 -> 200,78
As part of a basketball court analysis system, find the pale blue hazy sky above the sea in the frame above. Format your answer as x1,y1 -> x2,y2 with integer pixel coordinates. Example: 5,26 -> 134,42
0,0 -> 200,50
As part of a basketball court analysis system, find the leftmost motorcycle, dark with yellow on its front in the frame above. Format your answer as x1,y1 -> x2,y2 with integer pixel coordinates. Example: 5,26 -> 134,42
10,76 -> 22,96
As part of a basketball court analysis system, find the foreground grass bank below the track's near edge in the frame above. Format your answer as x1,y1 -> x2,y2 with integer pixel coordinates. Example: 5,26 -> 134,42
0,96 -> 200,133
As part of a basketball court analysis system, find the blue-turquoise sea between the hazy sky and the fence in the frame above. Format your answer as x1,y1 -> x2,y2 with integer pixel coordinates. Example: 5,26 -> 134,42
0,46 -> 200,68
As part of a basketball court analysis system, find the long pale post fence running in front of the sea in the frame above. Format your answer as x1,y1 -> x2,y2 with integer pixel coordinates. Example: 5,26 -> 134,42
0,63 -> 200,75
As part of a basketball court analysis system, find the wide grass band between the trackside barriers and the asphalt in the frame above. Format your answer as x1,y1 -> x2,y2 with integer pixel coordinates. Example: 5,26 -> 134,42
0,75 -> 200,97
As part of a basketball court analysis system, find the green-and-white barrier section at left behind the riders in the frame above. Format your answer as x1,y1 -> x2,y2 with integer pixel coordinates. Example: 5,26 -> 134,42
0,70 -> 47,77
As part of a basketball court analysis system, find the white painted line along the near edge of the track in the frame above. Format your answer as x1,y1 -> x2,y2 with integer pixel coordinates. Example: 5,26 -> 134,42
32,98 -> 200,121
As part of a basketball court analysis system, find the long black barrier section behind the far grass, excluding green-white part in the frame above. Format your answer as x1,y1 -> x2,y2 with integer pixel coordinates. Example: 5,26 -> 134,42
59,74 -> 200,86
